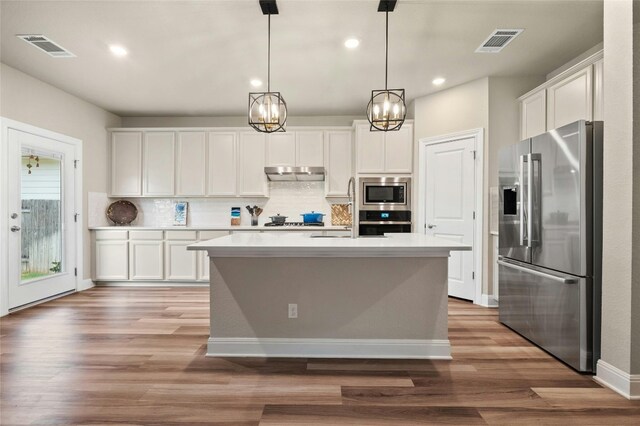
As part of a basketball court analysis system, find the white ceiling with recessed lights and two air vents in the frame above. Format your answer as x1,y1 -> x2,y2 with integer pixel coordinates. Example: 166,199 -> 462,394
0,0 -> 603,116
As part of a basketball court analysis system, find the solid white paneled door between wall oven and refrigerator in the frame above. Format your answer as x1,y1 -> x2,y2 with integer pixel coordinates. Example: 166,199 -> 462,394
423,138 -> 476,300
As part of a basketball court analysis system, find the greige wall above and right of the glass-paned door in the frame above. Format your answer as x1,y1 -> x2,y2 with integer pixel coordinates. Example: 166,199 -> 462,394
0,64 -> 121,278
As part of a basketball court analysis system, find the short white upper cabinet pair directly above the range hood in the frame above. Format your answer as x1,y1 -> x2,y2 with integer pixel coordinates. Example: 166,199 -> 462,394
266,130 -> 324,167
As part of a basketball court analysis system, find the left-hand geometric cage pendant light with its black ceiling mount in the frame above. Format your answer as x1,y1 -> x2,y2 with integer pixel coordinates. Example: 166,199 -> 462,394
249,0 -> 287,133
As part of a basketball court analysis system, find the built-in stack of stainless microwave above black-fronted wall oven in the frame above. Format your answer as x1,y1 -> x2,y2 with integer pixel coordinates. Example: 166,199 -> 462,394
358,177 -> 411,235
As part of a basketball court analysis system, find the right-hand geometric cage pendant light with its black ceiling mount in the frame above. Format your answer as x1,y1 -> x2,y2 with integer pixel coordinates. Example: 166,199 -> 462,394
367,0 -> 407,132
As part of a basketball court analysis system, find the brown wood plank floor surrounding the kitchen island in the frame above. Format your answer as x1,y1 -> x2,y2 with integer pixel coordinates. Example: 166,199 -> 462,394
0,287 -> 640,425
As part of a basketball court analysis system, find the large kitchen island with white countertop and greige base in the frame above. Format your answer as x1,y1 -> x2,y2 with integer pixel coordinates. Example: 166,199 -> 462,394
188,233 -> 470,359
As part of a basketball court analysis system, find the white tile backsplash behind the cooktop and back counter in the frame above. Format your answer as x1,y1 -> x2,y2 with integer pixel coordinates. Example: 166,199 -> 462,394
97,182 -> 338,227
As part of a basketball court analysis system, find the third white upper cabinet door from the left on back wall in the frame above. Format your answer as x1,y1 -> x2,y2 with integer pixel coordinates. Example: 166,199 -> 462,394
176,132 -> 207,197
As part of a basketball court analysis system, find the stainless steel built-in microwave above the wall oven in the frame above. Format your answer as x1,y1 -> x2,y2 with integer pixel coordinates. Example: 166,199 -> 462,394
359,177 -> 411,210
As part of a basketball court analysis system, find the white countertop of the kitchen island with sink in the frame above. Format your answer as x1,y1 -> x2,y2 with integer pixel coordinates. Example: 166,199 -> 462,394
187,232 -> 471,257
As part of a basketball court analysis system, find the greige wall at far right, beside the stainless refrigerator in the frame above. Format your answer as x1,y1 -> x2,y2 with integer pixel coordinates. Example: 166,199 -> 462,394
602,1 -> 640,374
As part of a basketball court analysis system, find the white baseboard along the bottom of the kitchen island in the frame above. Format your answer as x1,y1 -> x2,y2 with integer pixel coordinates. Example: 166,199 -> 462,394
207,337 -> 451,359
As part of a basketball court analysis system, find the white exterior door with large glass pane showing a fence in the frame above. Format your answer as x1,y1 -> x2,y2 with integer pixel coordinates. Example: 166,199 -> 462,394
8,129 -> 77,309
